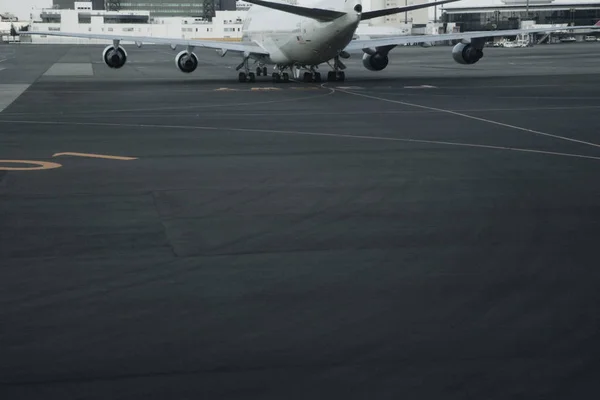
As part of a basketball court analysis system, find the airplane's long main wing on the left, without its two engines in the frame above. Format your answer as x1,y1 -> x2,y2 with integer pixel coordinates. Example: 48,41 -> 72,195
19,31 -> 269,55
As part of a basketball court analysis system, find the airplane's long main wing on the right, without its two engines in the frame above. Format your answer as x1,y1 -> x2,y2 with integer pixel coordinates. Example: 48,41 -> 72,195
344,24 -> 600,51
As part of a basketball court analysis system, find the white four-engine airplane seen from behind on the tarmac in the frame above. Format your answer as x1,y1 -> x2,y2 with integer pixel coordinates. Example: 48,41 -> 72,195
19,0 -> 600,83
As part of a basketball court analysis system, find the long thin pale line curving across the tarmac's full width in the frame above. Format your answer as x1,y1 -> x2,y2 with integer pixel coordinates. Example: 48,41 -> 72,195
0,120 -> 600,161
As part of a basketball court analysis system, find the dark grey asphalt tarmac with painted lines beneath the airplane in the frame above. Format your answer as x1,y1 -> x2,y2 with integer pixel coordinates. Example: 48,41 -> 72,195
0,43 -> 600,400
